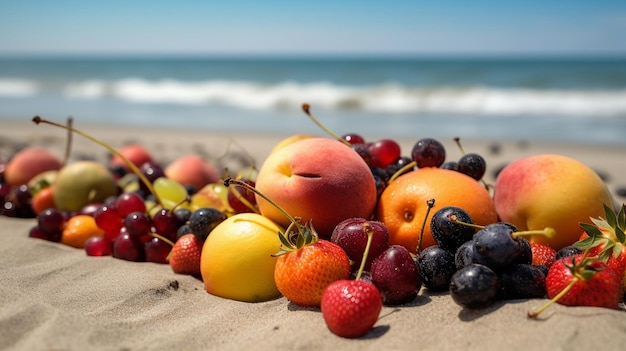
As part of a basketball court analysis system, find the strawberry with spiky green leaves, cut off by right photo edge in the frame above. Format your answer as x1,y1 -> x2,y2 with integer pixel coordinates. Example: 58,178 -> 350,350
574,204 -> 626,289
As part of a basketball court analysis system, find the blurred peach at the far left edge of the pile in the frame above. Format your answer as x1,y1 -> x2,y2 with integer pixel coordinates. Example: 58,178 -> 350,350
4,147 -> 63,185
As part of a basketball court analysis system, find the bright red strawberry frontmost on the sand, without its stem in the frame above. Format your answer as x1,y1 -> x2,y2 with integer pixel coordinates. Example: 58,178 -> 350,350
321,280 -> 383,338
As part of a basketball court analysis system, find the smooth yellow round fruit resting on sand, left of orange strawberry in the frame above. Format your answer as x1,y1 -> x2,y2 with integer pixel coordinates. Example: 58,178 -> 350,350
200,213 -> 283,302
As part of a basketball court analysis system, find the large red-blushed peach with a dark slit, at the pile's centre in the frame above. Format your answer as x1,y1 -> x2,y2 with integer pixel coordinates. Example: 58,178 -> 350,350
256,137 -> 376,238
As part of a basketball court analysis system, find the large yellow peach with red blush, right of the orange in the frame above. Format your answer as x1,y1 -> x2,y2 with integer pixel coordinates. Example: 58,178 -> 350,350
494,154 -> 614,250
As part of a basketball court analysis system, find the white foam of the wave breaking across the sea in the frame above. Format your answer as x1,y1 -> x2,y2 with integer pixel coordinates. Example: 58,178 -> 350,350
0,78 -> 626,117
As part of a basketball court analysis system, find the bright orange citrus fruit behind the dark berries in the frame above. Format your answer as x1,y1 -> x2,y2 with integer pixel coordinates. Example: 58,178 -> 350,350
376,168 -> 498,253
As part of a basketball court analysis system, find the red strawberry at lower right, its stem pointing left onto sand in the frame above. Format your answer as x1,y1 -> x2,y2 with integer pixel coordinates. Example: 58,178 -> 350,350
528,252 -> 622,317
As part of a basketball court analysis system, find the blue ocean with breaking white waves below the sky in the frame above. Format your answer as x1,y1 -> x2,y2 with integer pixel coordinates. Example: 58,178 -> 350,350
0,57 -> 626,145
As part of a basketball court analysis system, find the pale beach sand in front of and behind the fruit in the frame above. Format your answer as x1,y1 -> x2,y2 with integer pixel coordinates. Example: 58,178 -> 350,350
0,121 -> 626,350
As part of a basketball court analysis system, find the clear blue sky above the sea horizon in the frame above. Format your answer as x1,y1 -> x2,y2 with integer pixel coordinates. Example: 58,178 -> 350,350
0,0 -> 626,57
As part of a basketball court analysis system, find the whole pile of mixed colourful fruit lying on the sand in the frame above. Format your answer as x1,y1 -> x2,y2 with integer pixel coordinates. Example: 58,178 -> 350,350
0,110 -> 626,337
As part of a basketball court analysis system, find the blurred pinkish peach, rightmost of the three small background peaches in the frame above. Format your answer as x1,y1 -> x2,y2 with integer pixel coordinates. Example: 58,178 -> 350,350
165,155 -> 220,190
